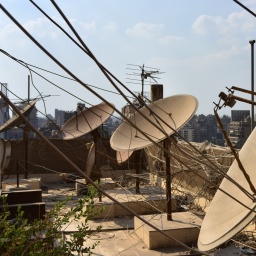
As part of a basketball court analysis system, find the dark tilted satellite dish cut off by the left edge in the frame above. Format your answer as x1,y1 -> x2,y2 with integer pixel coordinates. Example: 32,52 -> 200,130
0,100 -> 37,132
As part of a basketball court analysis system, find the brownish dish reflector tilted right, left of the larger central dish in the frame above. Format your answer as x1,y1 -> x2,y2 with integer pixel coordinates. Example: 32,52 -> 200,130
60,103 -> 114,140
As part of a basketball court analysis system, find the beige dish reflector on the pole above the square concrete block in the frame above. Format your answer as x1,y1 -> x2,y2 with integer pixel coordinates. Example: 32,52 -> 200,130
110,95 -> 198,151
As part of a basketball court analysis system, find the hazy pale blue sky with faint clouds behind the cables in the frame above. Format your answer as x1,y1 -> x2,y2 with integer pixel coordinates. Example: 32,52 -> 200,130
0,0 -> 256,118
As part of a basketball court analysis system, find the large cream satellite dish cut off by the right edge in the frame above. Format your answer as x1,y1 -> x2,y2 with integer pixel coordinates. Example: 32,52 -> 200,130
198,128 -> 256,251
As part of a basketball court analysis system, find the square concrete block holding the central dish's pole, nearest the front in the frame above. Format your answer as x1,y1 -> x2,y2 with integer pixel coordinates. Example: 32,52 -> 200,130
134,212 -> 202,249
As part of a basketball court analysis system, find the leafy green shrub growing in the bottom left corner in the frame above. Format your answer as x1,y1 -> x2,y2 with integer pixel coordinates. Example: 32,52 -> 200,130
0,188 -> 101,256
